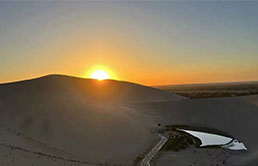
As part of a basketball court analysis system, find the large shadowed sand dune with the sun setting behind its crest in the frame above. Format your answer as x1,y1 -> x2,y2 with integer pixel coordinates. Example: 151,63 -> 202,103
0,75 -> 182,164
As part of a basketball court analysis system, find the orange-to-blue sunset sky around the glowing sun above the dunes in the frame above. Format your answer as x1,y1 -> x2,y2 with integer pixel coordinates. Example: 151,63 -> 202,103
0,1 -> 258,85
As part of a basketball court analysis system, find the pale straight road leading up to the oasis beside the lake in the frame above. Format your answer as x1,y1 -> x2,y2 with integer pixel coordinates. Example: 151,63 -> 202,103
141,134 -> 168,166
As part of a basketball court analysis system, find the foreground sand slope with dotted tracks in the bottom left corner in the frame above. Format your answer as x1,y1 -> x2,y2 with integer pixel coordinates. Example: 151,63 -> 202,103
0,122 -> 98,166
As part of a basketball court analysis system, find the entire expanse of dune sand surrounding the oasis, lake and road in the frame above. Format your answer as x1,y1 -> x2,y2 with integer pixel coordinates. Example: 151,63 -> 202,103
0,75 -> 258,166
